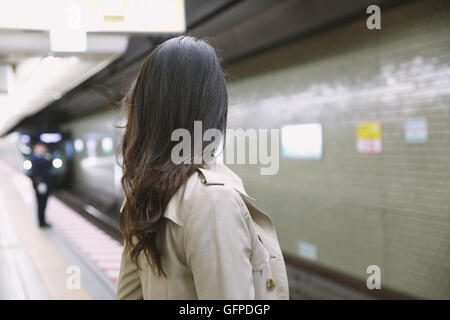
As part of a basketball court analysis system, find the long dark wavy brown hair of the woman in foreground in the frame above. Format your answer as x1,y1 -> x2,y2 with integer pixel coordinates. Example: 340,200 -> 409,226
120,36 -> 228,276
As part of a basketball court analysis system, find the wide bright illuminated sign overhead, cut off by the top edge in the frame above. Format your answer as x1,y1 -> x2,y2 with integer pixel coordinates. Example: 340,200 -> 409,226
0,0 -> 186,33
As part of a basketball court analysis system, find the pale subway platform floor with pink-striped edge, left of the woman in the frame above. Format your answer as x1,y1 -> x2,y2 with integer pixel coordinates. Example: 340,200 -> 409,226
0,161 -> 123,300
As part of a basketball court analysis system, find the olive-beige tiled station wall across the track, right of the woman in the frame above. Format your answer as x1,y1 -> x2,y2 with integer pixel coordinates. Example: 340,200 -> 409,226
227,1 -> 450,299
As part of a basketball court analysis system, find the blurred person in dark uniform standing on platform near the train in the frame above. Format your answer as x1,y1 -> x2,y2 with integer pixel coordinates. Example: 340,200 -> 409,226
30,143 -> 52,228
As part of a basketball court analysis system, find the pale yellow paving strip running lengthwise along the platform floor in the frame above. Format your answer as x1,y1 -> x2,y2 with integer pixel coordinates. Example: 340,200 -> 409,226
0,162 -> 91,299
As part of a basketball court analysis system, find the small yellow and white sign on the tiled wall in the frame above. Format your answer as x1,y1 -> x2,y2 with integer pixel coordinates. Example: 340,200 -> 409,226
356,121 -> 382,153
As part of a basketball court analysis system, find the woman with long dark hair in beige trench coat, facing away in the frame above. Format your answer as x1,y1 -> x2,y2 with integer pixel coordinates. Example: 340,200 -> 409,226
117,36 -> 288,299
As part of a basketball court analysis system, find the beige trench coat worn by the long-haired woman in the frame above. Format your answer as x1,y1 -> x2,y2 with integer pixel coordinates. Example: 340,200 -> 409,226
117,164 -> 289,300
